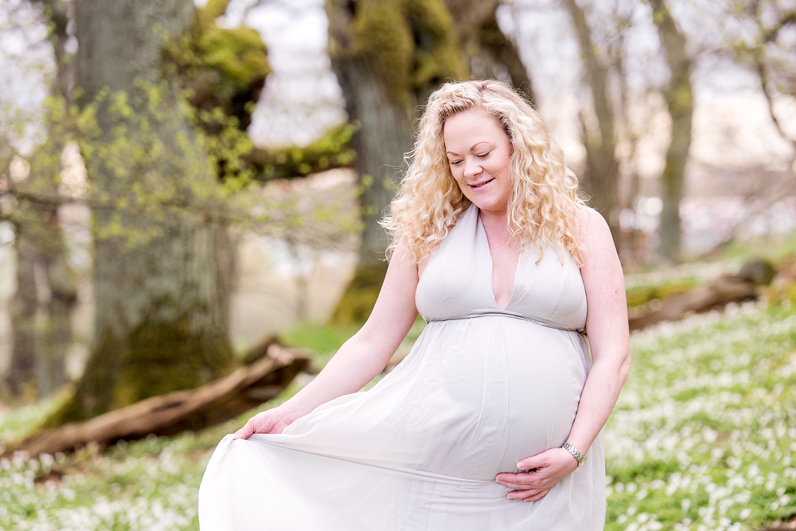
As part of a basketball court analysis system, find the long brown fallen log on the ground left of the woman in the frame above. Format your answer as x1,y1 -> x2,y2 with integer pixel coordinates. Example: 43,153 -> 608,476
0,343 -> 310,457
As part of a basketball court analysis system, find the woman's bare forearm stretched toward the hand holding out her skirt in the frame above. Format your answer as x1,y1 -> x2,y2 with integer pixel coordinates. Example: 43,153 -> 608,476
285,336 -> 394,417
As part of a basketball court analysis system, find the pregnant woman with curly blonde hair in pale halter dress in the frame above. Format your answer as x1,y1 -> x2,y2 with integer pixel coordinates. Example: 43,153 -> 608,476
199,81 -> 630,531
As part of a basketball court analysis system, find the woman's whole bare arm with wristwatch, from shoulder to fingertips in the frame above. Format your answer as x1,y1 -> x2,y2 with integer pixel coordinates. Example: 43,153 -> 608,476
496,208 -> 630,501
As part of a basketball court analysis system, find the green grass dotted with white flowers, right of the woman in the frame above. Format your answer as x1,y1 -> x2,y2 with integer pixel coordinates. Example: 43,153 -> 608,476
605,306 -> 796,531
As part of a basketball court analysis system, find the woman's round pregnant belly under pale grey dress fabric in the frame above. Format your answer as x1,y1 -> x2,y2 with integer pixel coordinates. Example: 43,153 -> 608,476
410,316 -> 587,479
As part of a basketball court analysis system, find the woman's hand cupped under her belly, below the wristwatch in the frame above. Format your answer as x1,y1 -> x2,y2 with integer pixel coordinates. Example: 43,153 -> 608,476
495,448 -> 578,501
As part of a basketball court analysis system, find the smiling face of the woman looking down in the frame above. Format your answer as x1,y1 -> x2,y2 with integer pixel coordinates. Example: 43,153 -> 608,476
442,108 -> 512,214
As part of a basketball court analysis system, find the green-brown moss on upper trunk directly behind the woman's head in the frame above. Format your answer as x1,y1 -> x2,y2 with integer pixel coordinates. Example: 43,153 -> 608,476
340,0 -> 466,103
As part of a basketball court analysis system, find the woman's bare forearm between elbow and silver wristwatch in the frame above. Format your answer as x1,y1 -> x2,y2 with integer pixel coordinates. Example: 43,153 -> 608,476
567,356 -> 630,454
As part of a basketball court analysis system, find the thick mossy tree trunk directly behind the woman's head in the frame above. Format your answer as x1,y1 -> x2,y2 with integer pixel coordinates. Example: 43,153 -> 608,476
326,0 -> 531,324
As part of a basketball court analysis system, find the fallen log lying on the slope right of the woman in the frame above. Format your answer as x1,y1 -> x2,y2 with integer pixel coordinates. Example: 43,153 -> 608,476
628,260 -> 773,331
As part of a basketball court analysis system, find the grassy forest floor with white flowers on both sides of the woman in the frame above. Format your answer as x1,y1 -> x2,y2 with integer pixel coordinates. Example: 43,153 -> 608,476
0,262 -> 796,531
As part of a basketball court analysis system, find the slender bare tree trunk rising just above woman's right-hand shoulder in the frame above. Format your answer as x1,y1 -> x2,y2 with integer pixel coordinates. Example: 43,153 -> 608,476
564,0 -> 620,249
